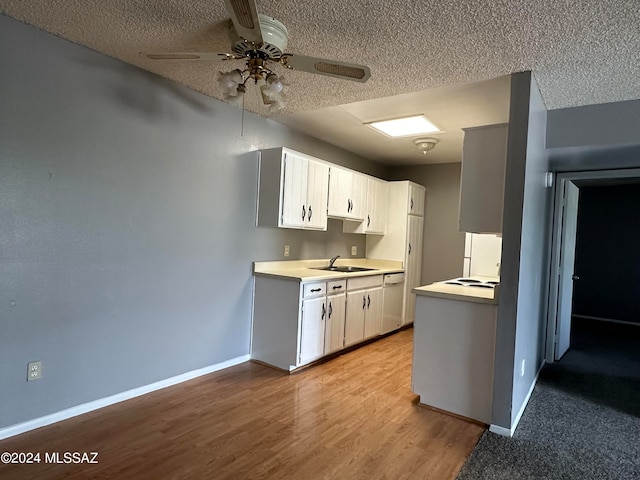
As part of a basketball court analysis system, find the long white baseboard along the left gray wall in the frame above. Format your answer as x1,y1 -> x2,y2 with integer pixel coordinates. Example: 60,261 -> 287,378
0,355 -> 251,440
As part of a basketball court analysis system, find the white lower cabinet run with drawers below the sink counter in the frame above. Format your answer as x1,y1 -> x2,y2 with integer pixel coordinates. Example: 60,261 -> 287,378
251,275 -> 382,371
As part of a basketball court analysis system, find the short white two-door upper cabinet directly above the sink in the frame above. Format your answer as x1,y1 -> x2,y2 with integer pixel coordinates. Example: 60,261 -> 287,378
327,165 -> 367,220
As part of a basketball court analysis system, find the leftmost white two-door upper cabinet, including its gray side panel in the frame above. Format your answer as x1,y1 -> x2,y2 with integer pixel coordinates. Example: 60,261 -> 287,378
256,148 -> 329,230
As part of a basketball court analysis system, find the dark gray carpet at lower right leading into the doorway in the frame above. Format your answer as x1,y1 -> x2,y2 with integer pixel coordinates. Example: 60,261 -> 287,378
457,319 -> 640,480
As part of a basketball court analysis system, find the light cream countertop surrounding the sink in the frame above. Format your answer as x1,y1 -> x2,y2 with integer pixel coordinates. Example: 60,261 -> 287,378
253,258 -> 404,282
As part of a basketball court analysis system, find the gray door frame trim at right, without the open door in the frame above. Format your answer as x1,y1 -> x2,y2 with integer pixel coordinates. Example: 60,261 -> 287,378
545,168 -> 640,363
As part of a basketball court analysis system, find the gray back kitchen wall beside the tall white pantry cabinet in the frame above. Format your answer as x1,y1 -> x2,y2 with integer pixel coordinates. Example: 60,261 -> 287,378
390,165 -> 464,285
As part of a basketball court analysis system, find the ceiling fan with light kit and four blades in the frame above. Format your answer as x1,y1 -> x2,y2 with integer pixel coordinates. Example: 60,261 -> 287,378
147,0 -> 371,108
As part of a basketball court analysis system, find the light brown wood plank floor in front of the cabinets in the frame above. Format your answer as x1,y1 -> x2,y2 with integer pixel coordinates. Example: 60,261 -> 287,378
0,329 -> 484,480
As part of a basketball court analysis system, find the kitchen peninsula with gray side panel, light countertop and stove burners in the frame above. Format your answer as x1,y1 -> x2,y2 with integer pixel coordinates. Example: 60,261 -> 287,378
412,276 -> 499,424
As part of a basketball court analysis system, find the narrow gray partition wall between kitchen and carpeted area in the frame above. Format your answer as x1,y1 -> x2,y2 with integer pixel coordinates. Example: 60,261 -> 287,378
492,72 -> 550,429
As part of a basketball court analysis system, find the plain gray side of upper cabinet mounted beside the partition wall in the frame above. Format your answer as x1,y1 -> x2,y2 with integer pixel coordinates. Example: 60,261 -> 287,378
459,124 -> 508,233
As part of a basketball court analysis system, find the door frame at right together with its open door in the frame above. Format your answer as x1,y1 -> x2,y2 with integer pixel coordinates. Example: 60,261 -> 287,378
545,169 -> 640,363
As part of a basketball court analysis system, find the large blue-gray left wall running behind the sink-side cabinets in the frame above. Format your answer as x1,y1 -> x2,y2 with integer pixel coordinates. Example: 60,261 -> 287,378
0,16 -> 385,428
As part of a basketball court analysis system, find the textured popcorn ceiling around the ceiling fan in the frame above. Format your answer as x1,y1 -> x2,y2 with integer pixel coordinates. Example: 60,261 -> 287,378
0,0 -> 640,163
